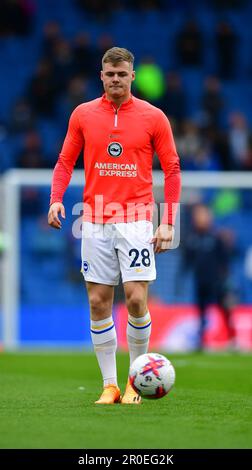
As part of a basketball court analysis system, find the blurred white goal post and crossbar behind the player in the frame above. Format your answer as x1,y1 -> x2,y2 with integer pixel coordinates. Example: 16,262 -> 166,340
0,169 -> 252,351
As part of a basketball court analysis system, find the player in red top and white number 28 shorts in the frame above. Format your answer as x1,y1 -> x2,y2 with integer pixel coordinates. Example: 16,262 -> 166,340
48,47 -> 180,404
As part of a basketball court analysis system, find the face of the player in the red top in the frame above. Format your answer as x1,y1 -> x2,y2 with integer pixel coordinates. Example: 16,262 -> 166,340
101,61 -> 135,101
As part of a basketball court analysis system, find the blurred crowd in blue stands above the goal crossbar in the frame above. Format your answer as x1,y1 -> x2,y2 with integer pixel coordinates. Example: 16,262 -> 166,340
0,0 -> 252,171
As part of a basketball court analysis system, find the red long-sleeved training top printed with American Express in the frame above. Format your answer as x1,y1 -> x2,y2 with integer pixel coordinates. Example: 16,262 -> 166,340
50,94 -> 181,224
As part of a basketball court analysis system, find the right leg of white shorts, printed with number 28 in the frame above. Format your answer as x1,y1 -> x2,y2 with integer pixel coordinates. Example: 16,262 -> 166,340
116,221 -> 156,283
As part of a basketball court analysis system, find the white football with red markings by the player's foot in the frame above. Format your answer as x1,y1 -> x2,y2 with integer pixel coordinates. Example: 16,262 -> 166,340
129,353 -> 175,398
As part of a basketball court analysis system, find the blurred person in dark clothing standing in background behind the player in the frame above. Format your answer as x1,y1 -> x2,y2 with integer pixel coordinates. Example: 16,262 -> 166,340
180,203 -> 236,350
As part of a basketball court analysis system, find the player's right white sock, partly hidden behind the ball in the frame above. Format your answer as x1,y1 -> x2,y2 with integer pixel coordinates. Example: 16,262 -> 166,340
127,312 -> 151,365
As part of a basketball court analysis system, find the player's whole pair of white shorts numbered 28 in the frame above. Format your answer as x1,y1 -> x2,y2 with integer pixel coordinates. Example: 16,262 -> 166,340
81,220 -> 156,286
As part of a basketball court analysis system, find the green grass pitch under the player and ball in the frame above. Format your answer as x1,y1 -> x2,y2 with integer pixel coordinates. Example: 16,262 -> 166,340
0,353 -> 252,449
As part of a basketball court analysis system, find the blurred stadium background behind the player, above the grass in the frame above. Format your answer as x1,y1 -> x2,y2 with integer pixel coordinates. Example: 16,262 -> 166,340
0,0 -> 252,351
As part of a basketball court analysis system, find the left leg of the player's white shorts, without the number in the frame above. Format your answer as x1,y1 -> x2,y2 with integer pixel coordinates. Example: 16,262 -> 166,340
81,222 -> 120,286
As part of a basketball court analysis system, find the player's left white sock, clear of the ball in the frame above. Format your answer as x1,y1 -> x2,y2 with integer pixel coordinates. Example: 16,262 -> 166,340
90,316 -> 117,386
